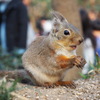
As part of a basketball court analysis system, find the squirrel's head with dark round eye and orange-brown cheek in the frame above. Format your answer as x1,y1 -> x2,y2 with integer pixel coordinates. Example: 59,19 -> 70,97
50,11 -> 83,51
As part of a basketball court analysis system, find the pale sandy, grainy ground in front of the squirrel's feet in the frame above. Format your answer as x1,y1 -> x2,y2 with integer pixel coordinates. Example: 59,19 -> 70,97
11,75 -> 100,100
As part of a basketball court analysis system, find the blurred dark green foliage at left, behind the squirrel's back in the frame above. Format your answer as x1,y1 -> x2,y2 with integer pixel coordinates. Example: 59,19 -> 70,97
0,49 -> 22,70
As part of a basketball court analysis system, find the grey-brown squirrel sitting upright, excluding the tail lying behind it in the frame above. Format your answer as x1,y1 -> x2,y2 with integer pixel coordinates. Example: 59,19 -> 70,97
22,11 -> 86,88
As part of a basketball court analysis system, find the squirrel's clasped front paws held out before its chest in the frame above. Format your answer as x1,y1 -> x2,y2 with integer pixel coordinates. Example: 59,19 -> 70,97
74,56 -> 86,68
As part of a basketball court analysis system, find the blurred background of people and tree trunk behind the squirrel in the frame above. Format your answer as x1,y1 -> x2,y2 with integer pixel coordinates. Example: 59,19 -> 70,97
0,0 -> 100,74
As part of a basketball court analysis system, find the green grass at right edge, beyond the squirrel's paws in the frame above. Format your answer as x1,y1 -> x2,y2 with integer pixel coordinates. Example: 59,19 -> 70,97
80,54 -> 100,79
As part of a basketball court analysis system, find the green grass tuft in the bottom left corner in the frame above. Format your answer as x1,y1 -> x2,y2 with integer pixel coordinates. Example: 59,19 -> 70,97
0,80 -> 17,100
